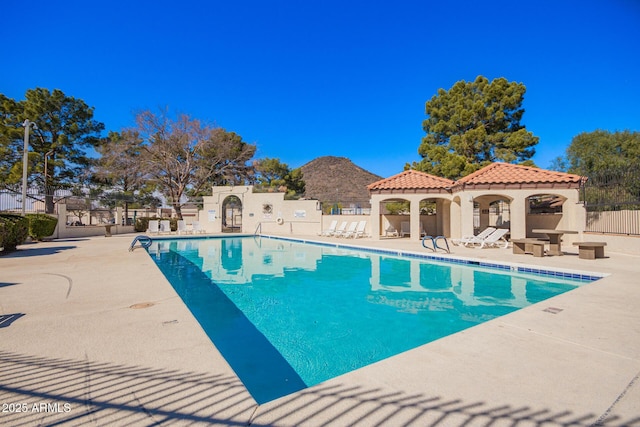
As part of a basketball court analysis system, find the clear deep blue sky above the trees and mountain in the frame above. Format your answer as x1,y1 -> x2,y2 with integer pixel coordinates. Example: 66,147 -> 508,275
0,0 -> 640,177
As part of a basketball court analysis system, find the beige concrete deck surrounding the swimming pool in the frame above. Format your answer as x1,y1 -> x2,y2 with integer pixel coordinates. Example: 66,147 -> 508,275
0,235 -> 640,426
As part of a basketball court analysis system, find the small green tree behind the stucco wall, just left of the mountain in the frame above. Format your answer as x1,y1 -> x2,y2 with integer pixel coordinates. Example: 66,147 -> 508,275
253,157 -> 305,199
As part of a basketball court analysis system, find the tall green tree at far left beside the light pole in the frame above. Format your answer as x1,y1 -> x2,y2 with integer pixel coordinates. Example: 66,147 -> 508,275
0,88 -> 104,213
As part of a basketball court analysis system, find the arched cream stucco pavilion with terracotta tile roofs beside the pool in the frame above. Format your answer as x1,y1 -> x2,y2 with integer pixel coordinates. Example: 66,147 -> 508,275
368,163 -> 585,244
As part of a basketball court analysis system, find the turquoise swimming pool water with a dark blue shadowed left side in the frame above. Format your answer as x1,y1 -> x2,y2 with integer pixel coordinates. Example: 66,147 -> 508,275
148,237 -> 595,403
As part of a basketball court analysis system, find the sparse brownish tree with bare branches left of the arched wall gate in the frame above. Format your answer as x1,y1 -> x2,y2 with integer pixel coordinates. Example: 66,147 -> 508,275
136,111 -> 256,218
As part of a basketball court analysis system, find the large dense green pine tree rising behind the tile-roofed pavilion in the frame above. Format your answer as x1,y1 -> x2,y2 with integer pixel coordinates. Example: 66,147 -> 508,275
405,76 -> 538,180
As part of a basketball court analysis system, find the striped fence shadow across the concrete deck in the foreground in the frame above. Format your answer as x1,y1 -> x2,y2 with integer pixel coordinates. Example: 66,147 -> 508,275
0,351 -> 640,427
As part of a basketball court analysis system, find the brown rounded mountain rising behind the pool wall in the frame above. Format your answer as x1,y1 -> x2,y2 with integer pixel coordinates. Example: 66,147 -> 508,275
301,156 -> 382,207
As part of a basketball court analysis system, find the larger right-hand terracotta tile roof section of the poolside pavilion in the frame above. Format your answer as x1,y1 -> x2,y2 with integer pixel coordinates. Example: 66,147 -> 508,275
456,162 -> 582,186
